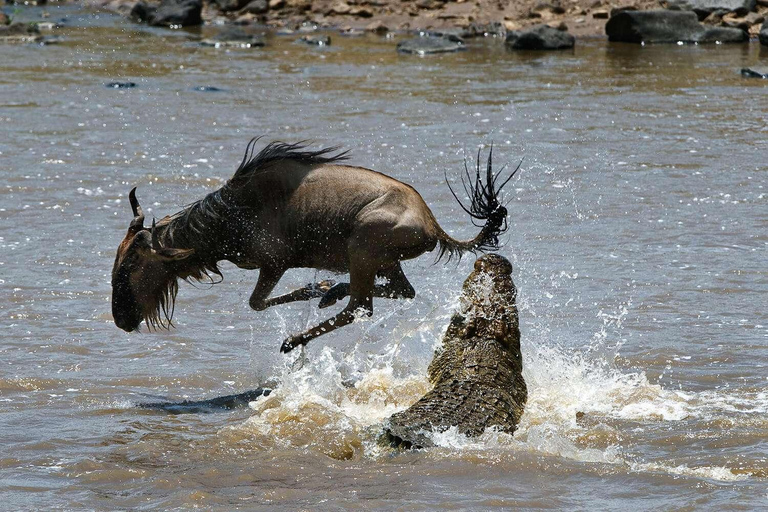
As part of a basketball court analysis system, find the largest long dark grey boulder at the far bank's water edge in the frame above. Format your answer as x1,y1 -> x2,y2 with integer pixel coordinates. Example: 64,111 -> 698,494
605,10 -> 749,43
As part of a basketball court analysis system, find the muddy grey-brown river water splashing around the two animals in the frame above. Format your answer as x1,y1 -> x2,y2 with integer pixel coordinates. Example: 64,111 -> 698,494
0,7 -> 768,510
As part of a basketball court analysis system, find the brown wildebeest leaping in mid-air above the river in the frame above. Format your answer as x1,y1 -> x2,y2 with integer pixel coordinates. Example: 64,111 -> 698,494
112,139 -> 519,352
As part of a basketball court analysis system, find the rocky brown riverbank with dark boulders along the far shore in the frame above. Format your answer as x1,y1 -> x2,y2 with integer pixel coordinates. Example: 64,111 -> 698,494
0,0 -> 768,48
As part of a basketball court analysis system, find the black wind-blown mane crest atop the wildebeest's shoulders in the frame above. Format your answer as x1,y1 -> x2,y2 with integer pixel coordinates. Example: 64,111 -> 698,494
227,137 -> 349,187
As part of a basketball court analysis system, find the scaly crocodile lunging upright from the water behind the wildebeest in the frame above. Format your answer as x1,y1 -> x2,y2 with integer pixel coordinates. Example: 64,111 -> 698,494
385,254 -> 528,448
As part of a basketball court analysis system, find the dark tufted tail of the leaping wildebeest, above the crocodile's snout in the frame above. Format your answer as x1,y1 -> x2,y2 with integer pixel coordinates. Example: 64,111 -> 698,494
435,145 -> 522,261
